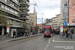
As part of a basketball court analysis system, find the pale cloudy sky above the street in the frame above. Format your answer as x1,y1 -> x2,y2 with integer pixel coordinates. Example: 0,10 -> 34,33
29,0 -> 60,24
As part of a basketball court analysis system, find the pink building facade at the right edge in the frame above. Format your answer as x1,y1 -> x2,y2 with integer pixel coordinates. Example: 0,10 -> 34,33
68,0 -> 75,33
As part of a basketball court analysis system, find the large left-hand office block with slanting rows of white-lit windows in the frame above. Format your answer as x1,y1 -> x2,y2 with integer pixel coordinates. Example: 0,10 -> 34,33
0,0 -> 28,36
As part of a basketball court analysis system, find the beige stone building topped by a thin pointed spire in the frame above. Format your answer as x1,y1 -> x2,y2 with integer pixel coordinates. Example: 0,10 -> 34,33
26,7 -> 37,31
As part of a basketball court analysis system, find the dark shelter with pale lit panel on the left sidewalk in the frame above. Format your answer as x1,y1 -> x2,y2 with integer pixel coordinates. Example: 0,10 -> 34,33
10,27 -> 25,37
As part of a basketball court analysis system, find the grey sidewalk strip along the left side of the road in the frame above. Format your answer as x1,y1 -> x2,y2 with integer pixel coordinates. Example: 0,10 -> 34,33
0,33 -> 43,45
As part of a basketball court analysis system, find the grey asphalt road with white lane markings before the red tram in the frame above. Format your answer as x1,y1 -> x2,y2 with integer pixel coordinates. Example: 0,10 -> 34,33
0,35 -> 75,50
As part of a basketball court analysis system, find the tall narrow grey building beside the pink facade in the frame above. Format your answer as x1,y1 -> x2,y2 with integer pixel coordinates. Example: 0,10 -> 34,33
61,0 -> 68,24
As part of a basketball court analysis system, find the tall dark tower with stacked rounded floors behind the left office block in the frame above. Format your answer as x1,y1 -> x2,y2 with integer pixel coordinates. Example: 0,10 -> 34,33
19,0 -> 29,21
